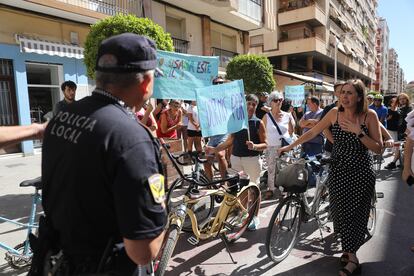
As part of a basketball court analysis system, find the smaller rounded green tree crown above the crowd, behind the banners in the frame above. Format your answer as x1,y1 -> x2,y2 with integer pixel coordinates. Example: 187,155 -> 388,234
226,55 -> 276,93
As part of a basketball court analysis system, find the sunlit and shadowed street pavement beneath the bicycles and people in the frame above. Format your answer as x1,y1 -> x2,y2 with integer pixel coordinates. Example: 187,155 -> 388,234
0,152 -> 414,276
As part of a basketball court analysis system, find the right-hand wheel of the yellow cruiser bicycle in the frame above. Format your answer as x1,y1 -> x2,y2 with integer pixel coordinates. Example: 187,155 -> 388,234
224,185 -> 260,242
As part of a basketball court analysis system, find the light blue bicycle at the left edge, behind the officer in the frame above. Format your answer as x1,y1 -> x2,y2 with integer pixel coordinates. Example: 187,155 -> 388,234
0,177 -> 42,269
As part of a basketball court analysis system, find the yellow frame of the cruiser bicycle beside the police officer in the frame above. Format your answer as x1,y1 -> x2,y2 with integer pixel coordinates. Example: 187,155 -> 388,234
170,184 -> 254,240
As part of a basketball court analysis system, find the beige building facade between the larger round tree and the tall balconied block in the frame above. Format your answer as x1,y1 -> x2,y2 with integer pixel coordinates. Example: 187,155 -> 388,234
151,0 -> 263,70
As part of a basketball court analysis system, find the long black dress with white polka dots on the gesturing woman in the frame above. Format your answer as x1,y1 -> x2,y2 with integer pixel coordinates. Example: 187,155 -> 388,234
328,113 -> 375,253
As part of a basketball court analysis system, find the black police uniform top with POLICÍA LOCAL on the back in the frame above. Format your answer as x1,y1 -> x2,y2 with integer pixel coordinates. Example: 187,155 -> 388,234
42,91 -> 166,275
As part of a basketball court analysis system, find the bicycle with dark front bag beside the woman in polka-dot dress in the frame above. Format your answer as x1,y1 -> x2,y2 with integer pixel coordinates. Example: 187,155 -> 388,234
265,155 -> 331,263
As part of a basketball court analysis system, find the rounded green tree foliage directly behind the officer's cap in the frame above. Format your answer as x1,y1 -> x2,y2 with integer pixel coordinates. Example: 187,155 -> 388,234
84,14 -> 174,78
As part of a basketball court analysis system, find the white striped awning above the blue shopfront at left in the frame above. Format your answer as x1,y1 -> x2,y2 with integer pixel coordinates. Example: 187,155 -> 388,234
16,34 -> 84,59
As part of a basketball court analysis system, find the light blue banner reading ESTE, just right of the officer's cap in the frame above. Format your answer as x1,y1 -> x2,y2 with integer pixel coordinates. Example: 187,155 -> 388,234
153,50 -> 219,100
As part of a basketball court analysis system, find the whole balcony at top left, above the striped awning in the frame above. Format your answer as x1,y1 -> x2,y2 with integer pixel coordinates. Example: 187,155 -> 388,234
2,0 -> 143,24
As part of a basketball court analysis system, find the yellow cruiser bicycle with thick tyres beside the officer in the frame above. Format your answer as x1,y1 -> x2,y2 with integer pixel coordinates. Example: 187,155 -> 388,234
153,141 -> 260,276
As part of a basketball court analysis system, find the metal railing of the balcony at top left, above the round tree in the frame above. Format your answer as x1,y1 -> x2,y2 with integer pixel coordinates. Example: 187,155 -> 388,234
56,0 -> 142,16
